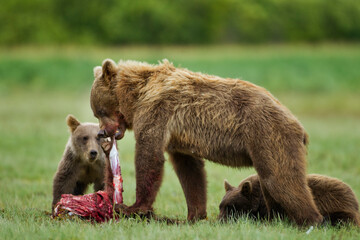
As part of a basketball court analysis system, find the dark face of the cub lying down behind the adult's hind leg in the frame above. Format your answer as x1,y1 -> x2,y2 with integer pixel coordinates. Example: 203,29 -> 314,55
218,180 -> 252,221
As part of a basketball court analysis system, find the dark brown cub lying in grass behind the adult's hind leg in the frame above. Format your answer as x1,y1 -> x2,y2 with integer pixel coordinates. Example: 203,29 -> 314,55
219,174 -> 360,226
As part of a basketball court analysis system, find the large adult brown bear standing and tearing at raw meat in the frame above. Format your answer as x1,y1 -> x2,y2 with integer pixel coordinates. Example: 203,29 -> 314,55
90,60 -> 323,225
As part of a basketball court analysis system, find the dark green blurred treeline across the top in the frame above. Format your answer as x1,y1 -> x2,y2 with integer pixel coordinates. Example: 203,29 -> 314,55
0,0 -> 360,45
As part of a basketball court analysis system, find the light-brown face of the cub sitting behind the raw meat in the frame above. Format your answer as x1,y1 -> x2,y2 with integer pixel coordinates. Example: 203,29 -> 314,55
67,115 -> 105,163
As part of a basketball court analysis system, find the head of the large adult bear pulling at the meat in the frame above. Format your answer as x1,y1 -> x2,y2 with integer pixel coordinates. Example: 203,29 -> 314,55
90,60 -> 125,140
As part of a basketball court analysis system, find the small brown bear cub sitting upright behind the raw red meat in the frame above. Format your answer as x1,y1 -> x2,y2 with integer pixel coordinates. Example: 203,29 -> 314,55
52,115 -> 105,213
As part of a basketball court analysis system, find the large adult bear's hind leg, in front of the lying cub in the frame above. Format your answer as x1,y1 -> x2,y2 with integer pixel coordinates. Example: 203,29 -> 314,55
250,141 -> 323,226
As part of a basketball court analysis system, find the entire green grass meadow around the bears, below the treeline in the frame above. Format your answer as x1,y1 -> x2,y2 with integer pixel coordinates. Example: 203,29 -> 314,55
0,45 -> 360,239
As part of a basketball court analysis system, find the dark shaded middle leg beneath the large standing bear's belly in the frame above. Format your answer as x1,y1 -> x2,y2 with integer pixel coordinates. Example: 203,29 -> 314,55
169,153 -> 206,221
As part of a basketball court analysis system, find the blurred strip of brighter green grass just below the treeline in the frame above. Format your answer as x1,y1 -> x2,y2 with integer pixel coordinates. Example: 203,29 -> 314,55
0,45 -> 360,93
